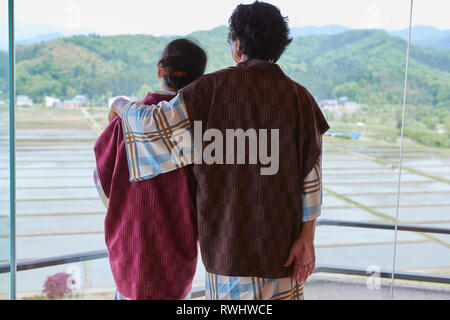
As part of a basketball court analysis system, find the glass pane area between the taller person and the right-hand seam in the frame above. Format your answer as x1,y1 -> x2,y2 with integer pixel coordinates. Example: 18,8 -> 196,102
288,0 -> 417,299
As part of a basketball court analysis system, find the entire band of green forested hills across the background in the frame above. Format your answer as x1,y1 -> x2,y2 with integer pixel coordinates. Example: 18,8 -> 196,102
0,27 -> 450,107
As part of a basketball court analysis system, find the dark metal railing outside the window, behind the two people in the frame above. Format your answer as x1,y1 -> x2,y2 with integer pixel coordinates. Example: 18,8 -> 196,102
0,219 -> 450,290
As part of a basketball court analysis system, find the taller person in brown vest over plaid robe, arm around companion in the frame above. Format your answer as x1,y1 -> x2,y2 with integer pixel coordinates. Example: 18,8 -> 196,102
111,1 -> 329,300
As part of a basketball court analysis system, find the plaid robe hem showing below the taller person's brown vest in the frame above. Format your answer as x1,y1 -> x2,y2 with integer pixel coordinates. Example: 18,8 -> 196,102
205,272 -> 303,300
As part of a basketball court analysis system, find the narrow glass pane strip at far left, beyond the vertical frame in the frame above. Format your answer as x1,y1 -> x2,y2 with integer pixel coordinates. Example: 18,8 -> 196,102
0,0 -> 11,299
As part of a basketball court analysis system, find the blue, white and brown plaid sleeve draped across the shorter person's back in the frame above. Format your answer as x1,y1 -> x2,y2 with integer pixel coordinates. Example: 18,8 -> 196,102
122,95 -> 193,182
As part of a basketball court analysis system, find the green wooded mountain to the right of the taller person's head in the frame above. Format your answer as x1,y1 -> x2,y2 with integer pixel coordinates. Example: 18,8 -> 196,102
280,30 -> 450,106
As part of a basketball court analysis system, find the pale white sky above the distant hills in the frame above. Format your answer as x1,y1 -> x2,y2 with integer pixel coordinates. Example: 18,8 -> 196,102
0,0 -> 450,36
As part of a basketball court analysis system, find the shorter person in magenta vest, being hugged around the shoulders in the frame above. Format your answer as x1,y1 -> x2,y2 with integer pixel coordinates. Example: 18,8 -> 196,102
94,39 -> 207,300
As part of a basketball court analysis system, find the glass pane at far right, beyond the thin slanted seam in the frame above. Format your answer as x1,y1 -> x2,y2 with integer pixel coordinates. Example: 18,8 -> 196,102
396,0 -> 450,295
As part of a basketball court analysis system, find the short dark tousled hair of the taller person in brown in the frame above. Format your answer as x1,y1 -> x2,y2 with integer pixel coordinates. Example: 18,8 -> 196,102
228,1 -> 292,63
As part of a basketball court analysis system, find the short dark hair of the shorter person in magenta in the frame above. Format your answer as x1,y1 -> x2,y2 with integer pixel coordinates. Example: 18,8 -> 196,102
158,39 -> 208,90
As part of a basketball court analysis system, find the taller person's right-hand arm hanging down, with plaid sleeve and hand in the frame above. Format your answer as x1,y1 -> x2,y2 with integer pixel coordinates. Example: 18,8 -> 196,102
284,161 -> 322,282
